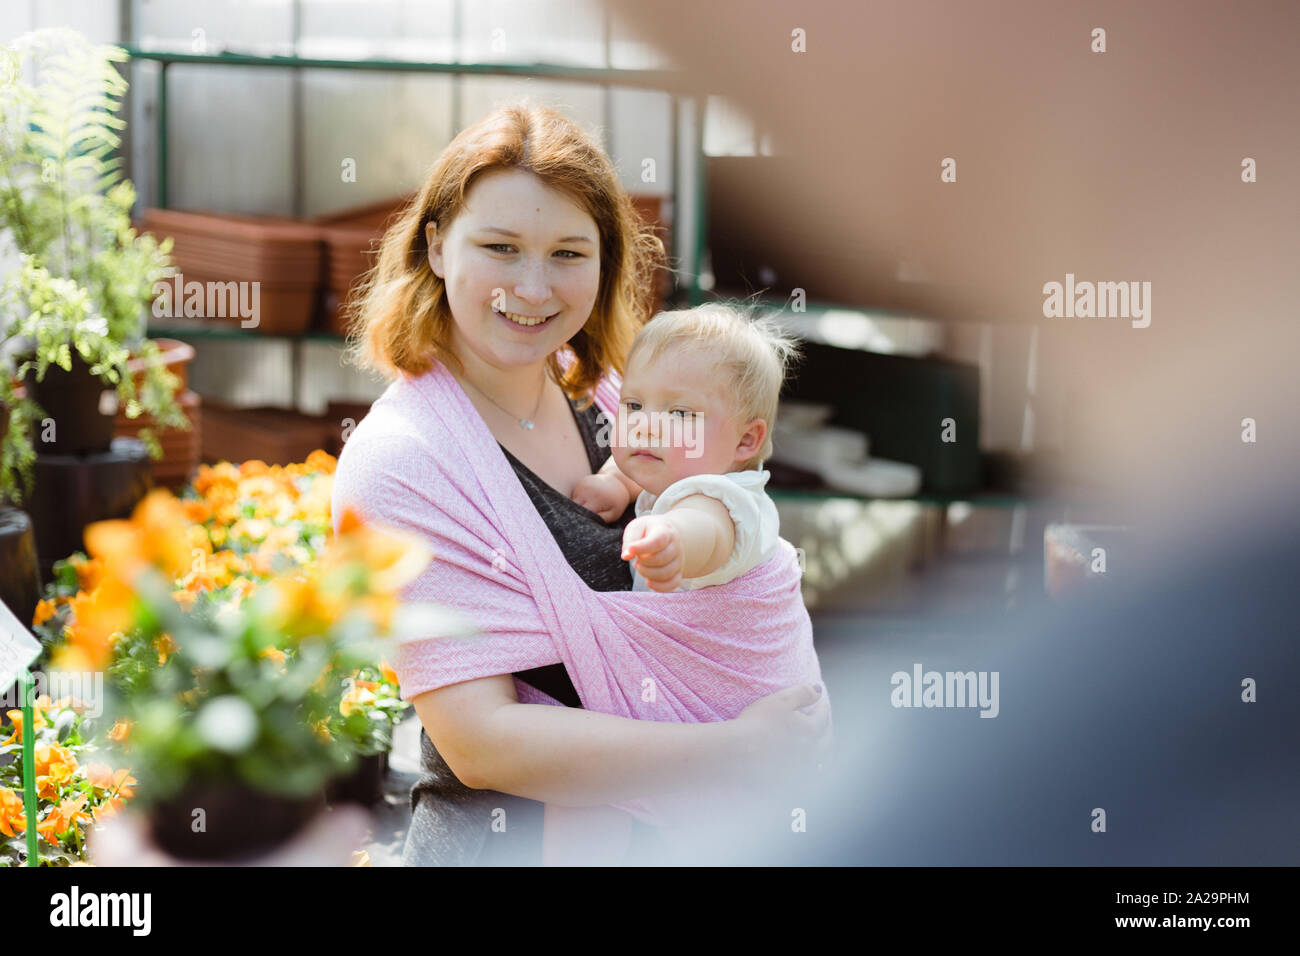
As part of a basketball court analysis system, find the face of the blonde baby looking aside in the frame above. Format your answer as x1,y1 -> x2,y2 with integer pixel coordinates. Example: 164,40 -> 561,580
611,347 -> 754,494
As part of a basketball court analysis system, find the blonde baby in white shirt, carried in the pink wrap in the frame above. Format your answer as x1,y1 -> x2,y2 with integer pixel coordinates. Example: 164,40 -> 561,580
542,304 -> 796,865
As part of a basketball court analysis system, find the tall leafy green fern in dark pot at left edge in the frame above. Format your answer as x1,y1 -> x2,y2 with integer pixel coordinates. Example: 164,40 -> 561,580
0,29 -> 189,503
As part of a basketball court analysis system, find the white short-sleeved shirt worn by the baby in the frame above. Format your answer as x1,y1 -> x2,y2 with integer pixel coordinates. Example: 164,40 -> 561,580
628,470 -> 780,591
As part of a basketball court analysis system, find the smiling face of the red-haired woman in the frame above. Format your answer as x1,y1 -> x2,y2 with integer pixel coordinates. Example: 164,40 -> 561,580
426,169 -> 601,369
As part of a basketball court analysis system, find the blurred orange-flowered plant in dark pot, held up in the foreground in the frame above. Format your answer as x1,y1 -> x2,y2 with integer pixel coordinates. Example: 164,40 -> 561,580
45,489 -> 471,861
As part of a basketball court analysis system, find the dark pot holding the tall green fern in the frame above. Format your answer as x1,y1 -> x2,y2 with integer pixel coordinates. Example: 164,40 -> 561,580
22,351 -> 117,455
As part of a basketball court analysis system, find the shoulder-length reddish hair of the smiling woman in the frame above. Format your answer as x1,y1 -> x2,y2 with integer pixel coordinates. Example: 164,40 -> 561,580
347,99 -> 666,403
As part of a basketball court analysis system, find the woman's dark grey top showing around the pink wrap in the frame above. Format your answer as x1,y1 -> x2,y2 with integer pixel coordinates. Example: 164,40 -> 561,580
402,399 -> 653,866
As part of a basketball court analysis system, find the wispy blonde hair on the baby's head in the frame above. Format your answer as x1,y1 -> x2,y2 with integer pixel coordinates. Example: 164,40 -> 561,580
628,302 -> 798,471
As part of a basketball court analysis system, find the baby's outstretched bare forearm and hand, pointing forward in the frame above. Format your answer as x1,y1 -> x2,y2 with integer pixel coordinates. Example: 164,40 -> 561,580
623,494 -> 736,592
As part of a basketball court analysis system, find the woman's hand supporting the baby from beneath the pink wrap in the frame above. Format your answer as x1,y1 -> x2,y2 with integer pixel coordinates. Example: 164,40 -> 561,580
735,684 -> 835,779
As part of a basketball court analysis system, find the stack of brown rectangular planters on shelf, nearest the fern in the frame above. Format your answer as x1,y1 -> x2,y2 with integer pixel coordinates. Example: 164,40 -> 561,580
142,209 -> 324,336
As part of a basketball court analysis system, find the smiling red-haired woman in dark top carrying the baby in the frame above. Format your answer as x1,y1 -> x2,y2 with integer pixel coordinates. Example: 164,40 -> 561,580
334,105 -> 828,865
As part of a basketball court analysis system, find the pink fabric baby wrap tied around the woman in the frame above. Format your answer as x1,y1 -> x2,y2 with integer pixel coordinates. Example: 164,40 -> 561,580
333,363 -> 822,826
